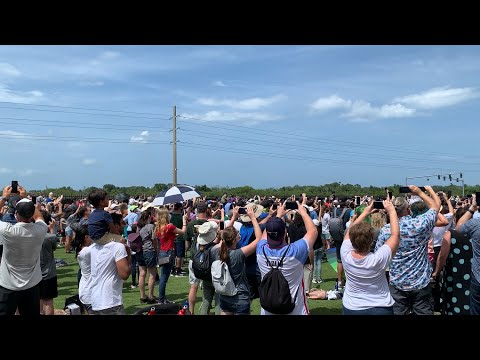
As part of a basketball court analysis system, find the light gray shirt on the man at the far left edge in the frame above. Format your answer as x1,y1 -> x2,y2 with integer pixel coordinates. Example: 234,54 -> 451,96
0,220 -> 48,291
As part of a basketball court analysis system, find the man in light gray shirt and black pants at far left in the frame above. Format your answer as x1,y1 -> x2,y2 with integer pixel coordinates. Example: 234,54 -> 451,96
0,186 -> 48,316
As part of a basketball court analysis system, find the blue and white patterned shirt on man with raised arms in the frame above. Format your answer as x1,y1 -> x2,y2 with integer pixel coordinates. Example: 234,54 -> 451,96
375,209 -> 437,291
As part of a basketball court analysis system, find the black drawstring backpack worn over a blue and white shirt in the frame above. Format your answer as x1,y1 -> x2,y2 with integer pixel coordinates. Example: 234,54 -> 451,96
258,244 -> 298,314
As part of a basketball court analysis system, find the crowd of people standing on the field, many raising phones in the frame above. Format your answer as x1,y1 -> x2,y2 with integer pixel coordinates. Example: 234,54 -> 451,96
0,185 -> 480,315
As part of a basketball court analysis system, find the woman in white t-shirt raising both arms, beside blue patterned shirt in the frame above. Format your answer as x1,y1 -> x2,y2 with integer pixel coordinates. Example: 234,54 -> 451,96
340,198 -> 400,315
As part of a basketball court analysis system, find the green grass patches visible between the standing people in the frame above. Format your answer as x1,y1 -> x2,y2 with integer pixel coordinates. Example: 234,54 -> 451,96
54,247 -> 342,315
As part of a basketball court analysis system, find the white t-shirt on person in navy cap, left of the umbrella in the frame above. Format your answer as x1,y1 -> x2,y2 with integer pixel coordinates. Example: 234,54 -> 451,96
90,241 -> 127,311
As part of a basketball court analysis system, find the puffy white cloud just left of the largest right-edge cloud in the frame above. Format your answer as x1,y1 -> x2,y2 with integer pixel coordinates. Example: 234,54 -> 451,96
343,100 -> 415,120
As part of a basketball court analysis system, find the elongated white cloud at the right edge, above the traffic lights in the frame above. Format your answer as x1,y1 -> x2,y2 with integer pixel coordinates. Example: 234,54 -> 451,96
394,87 -> 479,109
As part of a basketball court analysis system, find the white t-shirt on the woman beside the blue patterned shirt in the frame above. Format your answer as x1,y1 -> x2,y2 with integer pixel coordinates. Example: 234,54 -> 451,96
340,239 -> 395,310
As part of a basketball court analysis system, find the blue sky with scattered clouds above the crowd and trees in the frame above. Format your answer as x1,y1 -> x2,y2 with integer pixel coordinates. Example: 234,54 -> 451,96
0,45 -> 480,190
